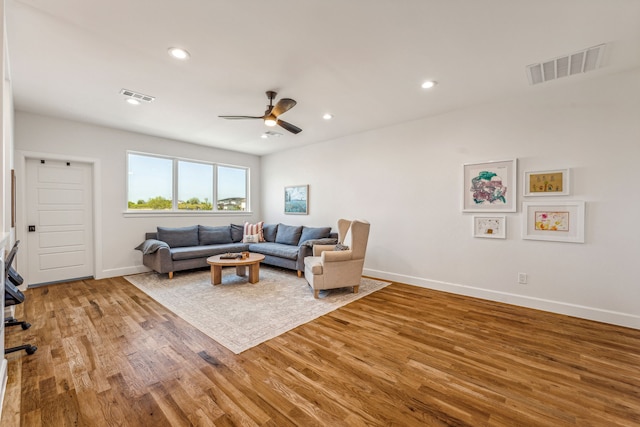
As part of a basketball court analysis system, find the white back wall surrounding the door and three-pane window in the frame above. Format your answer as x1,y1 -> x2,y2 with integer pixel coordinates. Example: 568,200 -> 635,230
15,111 -> 260,278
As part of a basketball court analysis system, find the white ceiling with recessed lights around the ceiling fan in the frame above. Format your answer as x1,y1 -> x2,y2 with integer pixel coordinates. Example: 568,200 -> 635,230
5,0 -> 640,155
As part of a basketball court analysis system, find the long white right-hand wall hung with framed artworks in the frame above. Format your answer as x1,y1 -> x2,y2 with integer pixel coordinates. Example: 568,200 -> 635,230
262,68 -> 640,328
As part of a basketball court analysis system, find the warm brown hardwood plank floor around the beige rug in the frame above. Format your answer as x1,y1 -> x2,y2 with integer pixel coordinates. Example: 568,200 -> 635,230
2,278 -> 640,427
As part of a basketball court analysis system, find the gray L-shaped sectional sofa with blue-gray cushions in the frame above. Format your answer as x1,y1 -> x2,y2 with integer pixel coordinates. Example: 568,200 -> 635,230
136,224 -> 338,278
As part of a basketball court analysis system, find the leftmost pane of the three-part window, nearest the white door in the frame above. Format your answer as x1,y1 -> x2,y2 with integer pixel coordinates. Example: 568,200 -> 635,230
127,154 -> 173,210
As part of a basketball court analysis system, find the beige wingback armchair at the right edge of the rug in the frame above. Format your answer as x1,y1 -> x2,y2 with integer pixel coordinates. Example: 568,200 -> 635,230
304,219 -> 370,298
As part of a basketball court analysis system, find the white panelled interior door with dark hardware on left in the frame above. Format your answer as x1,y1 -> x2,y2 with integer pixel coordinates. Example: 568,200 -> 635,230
22,159 -> 94,285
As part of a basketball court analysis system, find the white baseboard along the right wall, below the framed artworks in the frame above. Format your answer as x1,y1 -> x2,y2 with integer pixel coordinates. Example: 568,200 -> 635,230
363,268 -> 640,329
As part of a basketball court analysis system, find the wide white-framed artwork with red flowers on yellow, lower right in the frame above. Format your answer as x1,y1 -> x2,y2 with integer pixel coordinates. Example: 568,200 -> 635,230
522,201 -> 585,243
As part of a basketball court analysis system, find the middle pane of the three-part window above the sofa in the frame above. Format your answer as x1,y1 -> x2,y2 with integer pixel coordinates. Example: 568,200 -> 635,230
178,160 -> 213,211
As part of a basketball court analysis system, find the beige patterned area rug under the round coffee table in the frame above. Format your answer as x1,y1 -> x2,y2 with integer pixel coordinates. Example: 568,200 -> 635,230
125,266 -> 390,354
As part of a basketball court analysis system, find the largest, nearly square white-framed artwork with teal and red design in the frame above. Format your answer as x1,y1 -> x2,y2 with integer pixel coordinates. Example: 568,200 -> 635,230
462,159 -> 517,212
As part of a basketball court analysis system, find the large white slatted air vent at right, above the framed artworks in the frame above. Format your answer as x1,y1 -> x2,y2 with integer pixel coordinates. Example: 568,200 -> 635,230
527,44 -> 605,85
